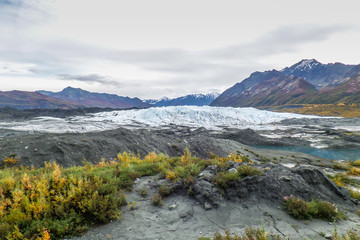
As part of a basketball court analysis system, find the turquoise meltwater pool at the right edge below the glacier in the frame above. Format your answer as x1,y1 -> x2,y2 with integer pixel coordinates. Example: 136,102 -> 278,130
256,146 -> 360,161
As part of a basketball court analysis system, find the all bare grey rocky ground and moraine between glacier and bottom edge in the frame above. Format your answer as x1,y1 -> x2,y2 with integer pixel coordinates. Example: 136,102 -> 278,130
0,109 -> 360,239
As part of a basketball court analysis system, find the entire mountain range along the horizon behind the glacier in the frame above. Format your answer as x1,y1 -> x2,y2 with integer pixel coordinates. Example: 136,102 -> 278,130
0,59 -> 360,109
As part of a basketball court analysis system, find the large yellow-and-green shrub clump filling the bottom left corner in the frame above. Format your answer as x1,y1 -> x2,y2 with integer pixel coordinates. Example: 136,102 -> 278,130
0,160 -> 125,240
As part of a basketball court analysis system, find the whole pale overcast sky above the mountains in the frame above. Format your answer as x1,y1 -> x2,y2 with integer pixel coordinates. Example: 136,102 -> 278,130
0,0 -> 360,99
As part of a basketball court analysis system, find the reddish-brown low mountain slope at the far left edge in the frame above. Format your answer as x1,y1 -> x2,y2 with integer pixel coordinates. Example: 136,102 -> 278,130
0,91 -> 84,110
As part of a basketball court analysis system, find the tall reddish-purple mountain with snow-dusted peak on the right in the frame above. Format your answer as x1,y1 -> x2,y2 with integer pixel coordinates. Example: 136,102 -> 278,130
210,59 -> 360,107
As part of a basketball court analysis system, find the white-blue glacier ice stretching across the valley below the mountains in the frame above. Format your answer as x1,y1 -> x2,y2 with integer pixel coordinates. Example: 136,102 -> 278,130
0,106 -> 323,133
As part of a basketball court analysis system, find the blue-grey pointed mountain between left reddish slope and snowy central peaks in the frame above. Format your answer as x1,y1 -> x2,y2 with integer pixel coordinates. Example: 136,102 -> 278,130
37,87 -> 150,108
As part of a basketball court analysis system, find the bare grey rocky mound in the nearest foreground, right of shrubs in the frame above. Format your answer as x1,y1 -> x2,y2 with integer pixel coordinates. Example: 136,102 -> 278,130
70,163 -> 360,239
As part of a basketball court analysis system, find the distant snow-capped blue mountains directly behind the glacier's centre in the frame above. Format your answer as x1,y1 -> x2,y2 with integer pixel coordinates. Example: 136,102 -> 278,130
144,92 -> 220,107
